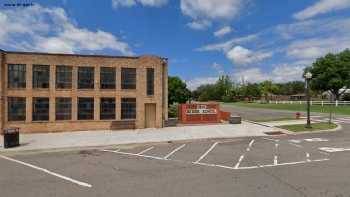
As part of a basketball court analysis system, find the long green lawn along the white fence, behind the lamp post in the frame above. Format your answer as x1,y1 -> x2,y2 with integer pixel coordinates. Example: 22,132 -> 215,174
227,102 -> 350,115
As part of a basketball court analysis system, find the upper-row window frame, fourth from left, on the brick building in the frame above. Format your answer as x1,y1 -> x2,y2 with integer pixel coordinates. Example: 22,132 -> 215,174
77,66 -> 95,90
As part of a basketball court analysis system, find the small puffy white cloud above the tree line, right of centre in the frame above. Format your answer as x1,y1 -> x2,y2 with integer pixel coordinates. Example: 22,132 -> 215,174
226,46 -> 272,65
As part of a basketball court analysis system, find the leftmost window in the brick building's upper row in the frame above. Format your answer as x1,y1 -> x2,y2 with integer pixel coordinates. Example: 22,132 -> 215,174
7,64 -> 26,88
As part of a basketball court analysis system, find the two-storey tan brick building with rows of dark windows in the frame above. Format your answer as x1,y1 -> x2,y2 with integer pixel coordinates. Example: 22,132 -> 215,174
0,50 -> 168,132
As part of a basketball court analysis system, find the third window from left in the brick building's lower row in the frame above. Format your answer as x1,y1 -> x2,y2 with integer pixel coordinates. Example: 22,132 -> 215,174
56,97 -> 72,120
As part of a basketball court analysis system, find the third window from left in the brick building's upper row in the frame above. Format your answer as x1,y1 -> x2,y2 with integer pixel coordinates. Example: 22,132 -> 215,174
56,66 -> 72,89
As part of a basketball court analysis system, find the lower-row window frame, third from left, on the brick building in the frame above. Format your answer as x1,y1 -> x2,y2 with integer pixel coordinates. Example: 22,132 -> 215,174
55,97 -> 72,121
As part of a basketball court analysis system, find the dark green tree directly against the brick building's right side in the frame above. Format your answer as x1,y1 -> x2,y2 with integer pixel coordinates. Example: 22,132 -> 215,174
168,76 -> 191,105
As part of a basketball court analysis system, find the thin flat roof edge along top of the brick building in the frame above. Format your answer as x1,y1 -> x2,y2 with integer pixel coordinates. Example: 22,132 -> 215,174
0,49 -> 168,60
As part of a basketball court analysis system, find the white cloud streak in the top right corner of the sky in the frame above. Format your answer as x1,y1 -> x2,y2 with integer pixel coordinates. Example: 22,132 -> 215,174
293,0 -> 350,20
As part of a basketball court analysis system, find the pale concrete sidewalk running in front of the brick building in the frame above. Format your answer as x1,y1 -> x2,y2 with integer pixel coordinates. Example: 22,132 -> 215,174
0,122 -> 279,152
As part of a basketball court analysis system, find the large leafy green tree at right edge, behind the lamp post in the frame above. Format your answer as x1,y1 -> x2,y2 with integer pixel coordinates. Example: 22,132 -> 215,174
305,49 -> 350,100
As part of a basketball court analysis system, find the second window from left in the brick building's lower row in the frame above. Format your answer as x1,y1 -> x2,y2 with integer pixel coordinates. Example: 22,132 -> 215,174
32,97 -> 50,121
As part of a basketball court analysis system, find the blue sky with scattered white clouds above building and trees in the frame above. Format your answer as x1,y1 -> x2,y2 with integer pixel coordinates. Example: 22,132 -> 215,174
0,0 -> 350,89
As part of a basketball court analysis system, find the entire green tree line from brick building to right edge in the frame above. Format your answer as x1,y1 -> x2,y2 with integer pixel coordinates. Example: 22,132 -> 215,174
168,49 -> 350,104
